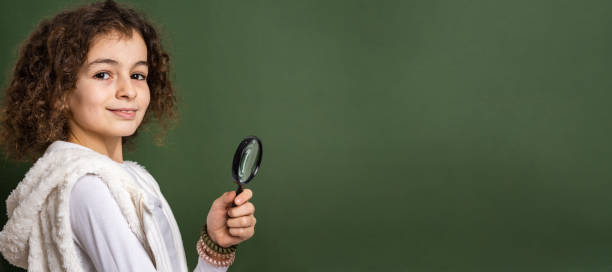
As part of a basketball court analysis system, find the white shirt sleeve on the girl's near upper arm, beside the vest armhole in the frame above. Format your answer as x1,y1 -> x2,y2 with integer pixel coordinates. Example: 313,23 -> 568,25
70,175 -> 155,271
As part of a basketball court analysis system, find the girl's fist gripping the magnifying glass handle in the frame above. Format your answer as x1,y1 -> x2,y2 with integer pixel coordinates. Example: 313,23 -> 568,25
206,189 -> 256,247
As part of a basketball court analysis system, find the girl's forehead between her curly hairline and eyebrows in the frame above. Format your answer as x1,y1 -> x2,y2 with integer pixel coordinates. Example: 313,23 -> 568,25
87,30 -> 147,63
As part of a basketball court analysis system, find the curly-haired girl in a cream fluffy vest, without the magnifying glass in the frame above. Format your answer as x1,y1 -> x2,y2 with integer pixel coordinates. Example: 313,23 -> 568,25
0,0 -> 255,271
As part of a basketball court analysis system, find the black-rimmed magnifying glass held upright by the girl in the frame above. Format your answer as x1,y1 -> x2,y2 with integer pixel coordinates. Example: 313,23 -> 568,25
232,136 -> 263,206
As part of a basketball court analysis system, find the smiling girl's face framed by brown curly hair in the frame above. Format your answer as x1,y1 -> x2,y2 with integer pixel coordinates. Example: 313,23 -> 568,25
68,28 -> 150,139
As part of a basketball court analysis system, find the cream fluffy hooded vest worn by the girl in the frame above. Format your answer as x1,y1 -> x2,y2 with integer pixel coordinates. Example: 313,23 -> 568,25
0,141 -> 187,271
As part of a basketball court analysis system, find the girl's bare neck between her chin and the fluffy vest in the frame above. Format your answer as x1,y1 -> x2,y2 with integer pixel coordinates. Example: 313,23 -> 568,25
68,125 -> 123,163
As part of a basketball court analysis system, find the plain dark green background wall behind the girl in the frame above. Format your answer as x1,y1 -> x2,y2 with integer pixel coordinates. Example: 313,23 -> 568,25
0,0 -> 612,271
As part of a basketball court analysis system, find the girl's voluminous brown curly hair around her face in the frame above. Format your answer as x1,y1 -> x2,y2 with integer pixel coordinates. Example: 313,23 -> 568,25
0,0 -> 178,161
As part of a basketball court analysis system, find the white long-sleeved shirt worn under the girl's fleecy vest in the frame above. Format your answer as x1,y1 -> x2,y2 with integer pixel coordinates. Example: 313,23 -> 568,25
70,154 -> 227,272
